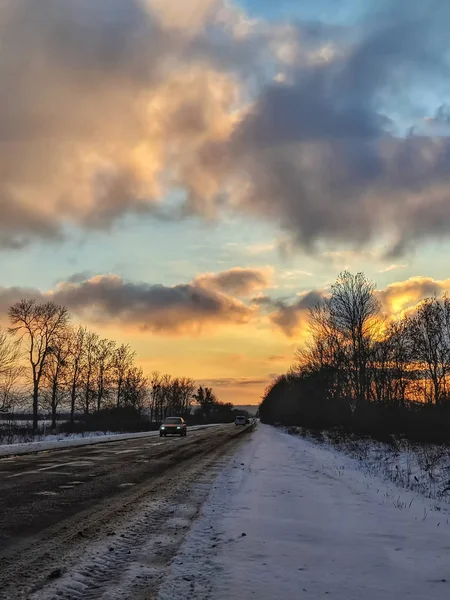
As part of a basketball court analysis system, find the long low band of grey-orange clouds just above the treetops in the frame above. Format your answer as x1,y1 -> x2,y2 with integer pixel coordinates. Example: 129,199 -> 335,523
0,269 -> 450,340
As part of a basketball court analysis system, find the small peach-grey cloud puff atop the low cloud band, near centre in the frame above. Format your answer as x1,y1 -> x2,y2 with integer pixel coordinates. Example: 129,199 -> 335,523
195,267 -> 272,296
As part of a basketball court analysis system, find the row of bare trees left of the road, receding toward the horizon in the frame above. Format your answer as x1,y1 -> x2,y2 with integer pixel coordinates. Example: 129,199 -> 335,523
0,300 -> 241,431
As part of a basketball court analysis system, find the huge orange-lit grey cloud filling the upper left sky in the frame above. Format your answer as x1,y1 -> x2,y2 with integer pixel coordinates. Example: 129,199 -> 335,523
0,0 -> 241,248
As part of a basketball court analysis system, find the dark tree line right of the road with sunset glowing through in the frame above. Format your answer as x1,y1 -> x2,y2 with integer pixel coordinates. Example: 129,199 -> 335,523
260,271 -> 450,439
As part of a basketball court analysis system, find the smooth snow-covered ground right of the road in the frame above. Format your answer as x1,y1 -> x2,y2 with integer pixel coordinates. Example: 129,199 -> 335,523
158,425 -> 450,600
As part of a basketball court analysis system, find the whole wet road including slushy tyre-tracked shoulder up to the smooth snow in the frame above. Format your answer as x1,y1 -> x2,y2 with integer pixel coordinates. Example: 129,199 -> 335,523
0,424 -> 252,600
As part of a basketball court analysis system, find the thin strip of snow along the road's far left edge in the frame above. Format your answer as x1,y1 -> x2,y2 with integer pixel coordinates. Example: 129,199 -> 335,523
0,425 -> 216,457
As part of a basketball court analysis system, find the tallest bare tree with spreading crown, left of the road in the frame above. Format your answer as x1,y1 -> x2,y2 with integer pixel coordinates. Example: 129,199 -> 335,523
9,300 -> 69,432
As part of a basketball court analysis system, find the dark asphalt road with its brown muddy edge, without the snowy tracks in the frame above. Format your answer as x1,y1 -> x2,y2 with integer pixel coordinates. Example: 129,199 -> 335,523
0,424 -> 251,599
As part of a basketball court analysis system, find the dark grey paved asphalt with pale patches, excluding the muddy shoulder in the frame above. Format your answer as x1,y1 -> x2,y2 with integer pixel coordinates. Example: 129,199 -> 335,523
0,425 -> 233,557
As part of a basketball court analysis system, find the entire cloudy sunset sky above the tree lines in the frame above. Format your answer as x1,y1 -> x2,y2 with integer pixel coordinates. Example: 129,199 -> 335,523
0,0 -> 450,404
